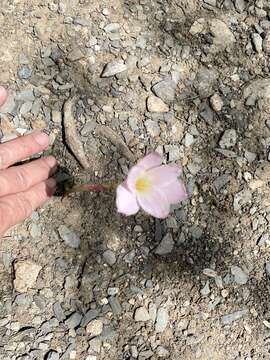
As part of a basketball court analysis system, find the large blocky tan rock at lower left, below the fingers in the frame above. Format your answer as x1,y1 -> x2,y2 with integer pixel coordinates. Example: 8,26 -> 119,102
14,260 -> 42,293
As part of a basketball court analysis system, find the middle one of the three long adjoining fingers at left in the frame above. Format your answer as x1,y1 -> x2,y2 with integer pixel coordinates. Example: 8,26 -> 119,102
0,156 -> 57,197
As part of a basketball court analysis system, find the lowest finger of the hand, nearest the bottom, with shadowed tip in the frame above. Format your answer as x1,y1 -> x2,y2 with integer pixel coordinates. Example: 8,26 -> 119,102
0,178 -> 56,234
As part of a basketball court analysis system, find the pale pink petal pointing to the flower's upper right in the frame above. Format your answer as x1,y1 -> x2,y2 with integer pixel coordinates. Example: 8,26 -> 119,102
147,165 -> 182,187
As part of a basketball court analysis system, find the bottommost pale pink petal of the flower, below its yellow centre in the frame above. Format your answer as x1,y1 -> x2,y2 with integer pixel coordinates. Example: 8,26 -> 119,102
137,188 -> 170,219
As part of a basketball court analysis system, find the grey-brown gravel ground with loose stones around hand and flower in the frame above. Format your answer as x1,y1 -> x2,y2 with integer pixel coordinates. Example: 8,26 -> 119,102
0,0 -> 270,360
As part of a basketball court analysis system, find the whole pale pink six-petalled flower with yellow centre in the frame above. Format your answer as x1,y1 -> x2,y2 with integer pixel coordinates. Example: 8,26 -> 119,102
116,153 -> 187,219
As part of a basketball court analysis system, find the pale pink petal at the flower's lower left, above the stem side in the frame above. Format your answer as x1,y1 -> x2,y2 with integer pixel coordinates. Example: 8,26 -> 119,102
116,183 -> 139,216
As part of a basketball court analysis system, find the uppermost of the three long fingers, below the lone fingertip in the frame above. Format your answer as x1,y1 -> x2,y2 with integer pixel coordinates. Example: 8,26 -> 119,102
0,131 -> 49,170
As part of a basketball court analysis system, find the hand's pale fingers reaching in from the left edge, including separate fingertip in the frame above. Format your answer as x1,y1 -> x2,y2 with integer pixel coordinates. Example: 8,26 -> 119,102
0,86 -> 57,237
